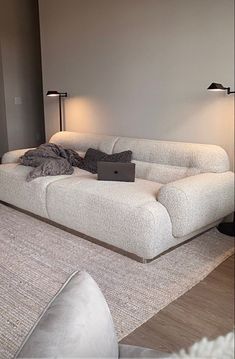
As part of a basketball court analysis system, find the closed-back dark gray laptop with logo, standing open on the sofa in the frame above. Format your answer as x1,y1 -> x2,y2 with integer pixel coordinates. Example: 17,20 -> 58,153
97,161 -> 135,182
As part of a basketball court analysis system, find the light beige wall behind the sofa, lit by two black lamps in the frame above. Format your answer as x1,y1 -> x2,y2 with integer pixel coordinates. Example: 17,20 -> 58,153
39,0 -> 234,167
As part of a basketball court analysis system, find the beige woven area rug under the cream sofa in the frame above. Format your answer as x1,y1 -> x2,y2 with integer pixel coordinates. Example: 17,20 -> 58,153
0,204 -> 233,359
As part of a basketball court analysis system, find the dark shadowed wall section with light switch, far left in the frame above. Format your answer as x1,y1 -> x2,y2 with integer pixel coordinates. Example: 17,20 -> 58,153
0,0 -> 44,150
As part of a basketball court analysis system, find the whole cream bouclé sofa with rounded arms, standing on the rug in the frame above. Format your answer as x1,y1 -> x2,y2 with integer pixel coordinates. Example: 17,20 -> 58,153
0,132 -> 234,259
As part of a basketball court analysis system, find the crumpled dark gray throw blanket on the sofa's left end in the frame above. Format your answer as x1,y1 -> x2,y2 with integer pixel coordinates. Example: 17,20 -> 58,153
20,143 -> 83,181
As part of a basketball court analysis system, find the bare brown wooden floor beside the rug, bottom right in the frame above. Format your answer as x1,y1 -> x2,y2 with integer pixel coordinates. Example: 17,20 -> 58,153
122,256 -> 234,352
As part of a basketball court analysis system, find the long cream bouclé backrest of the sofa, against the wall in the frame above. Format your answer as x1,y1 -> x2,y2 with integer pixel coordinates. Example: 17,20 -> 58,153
50,131 -> 229,183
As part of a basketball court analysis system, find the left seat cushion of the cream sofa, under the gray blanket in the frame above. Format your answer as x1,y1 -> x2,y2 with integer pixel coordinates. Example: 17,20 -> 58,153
0,163 -> 95,218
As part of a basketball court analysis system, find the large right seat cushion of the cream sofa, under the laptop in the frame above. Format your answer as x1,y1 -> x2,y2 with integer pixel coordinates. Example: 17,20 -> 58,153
47,175 -> 172,259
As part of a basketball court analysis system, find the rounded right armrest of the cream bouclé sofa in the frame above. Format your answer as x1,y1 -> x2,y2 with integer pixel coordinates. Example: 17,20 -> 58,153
158,171 -> 234,237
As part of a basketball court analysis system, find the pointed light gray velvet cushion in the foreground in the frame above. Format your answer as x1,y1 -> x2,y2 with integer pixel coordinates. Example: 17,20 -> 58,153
16,272 -> 118,359
